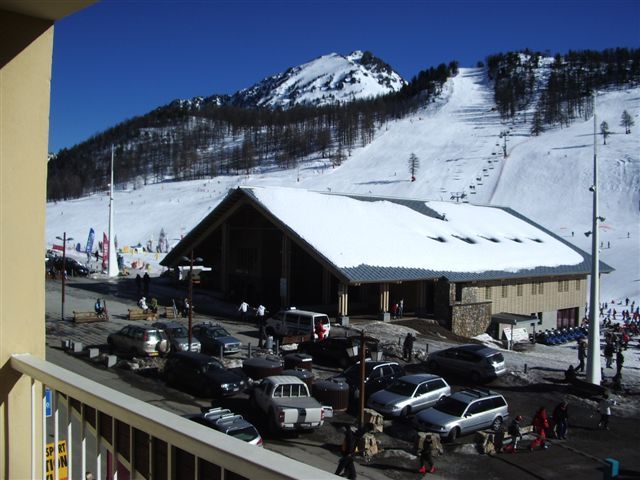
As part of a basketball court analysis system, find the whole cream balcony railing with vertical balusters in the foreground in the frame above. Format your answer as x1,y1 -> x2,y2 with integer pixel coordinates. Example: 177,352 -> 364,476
8,354 -> 336,480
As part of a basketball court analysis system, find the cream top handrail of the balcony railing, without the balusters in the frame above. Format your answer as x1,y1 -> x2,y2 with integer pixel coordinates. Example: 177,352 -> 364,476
11,353 -> 336,480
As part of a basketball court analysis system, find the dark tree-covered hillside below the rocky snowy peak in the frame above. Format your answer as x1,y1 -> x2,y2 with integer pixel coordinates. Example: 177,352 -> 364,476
47,62 -> 457,200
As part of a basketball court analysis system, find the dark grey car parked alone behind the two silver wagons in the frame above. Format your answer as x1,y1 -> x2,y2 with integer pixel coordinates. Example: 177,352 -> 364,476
426,344 -> 507,383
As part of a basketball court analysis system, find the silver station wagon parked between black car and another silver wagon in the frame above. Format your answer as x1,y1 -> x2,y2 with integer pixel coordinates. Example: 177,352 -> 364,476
367,373 -> 451,417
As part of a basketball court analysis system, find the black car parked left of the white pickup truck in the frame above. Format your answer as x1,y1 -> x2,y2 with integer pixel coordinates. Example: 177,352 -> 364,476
164,352 -> 249,398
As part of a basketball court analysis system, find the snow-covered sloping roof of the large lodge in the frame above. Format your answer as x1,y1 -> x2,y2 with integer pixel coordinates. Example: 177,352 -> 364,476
162,187 -> 611,282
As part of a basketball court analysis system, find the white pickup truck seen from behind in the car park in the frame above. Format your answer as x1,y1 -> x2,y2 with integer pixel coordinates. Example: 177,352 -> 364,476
251,375 -> 333,431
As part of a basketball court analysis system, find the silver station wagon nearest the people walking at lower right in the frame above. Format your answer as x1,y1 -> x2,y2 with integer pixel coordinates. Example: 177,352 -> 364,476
413,388 -> 509,441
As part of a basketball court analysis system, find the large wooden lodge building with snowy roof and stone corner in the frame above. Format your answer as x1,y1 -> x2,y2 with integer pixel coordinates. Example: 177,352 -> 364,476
161,187 -> 612,336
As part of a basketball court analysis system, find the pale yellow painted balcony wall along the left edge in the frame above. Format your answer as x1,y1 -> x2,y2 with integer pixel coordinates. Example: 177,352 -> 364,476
0,4 -> 53,478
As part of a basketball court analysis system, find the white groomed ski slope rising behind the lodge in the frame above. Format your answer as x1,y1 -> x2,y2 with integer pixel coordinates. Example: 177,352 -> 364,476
46,67 -> 640,301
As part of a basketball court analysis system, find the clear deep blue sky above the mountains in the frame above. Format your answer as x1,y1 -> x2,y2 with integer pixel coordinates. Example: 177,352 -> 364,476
49,0 -> 640,152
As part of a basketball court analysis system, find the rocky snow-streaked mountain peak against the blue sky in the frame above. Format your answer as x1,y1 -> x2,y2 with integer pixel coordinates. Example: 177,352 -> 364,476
225,50 -> 405,108
